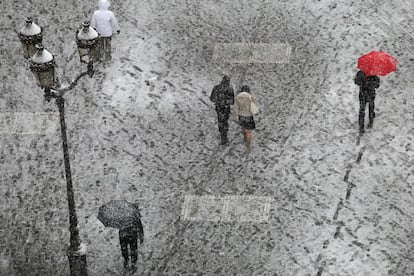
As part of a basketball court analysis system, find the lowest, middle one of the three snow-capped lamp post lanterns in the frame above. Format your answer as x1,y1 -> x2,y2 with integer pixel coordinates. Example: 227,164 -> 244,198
30,44 -> 56,88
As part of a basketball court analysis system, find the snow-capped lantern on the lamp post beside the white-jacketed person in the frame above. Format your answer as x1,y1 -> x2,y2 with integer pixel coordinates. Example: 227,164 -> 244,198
76,21 -> 100,63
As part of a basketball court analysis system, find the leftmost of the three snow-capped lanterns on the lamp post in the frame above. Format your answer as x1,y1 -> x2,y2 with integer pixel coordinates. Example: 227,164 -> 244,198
18,17 -> 42,59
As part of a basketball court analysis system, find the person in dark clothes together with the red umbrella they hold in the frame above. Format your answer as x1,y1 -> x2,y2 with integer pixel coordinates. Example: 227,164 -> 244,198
354,51 -> 397,135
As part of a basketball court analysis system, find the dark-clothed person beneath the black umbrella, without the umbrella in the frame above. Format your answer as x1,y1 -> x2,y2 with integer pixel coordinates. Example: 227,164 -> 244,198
119,212 -> 144,271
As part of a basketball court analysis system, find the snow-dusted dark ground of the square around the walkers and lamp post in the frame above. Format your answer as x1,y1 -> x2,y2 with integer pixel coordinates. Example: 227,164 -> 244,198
0,0 -> 414,276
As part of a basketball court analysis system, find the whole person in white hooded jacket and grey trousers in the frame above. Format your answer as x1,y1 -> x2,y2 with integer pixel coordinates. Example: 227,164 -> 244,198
91,0 -> 119,60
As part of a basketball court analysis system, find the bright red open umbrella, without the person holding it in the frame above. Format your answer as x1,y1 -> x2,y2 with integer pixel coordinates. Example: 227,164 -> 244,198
357,51 -> 397,76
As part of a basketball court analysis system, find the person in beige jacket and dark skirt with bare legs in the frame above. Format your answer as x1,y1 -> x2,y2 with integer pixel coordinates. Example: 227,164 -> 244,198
234,85 -> 259,152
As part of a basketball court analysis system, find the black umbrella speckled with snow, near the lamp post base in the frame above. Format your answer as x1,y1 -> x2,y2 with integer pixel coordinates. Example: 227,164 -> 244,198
98,200 -> 141,229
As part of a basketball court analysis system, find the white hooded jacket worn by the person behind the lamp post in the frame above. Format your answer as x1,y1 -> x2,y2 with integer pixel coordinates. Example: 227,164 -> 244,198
91,0 -> 119,37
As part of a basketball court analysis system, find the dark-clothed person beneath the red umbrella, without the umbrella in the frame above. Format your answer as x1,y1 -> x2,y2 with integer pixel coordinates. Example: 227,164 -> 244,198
354,71 -> 380,134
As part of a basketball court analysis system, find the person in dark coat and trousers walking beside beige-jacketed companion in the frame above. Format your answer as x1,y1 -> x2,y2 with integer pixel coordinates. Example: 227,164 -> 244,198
210,75 -> 234,145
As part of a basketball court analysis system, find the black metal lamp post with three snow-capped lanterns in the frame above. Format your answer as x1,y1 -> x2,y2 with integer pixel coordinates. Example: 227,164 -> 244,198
19,19 -> 100,276
